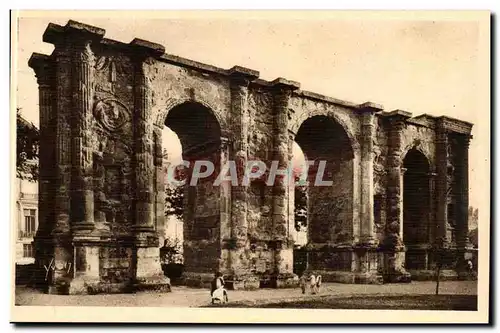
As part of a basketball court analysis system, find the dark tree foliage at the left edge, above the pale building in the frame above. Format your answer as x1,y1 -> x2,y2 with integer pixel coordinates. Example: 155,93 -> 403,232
16,108 -> 40,181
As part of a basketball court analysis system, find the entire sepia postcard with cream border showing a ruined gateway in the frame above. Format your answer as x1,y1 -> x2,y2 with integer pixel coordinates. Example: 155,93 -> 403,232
9,10 -> 492,324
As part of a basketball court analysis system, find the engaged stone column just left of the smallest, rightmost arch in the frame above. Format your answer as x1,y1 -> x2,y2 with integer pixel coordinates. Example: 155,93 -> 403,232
384,110 -> 411,282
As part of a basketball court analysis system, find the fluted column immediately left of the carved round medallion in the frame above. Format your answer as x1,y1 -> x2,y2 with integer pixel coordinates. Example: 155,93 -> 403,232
71,35 -> 95,233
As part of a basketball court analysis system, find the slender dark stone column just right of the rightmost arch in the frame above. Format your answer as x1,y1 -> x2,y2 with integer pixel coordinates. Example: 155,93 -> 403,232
434,123 -> 451,243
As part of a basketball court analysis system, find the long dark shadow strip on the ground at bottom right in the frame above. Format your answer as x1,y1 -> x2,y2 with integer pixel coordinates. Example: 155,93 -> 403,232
206,295 -> 477,311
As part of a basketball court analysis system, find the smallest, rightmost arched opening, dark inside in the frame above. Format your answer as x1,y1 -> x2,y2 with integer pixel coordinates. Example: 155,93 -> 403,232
403,148 -> 430,269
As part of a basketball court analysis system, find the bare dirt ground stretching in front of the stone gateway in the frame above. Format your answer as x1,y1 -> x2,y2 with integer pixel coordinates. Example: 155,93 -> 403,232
15,281 -> 477,308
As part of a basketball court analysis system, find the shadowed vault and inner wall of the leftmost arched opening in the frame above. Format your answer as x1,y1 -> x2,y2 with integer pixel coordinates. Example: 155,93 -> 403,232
163,102 -> 221,273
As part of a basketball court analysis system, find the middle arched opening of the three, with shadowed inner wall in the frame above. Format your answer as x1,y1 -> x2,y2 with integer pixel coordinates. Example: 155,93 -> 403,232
295,115 -> 354,271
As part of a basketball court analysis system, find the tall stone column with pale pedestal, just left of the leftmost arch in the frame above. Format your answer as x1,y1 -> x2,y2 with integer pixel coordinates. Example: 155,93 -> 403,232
130,39 -> 169,290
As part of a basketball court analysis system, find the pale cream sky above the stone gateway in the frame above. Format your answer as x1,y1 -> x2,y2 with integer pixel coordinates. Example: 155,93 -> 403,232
16,12 -> 490,219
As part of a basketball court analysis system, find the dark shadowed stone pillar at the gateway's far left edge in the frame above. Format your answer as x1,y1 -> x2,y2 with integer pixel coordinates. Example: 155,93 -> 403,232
28,53 -> 56,287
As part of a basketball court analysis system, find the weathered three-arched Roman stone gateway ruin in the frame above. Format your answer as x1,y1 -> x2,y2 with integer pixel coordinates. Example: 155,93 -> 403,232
29,21 -> 472,294
